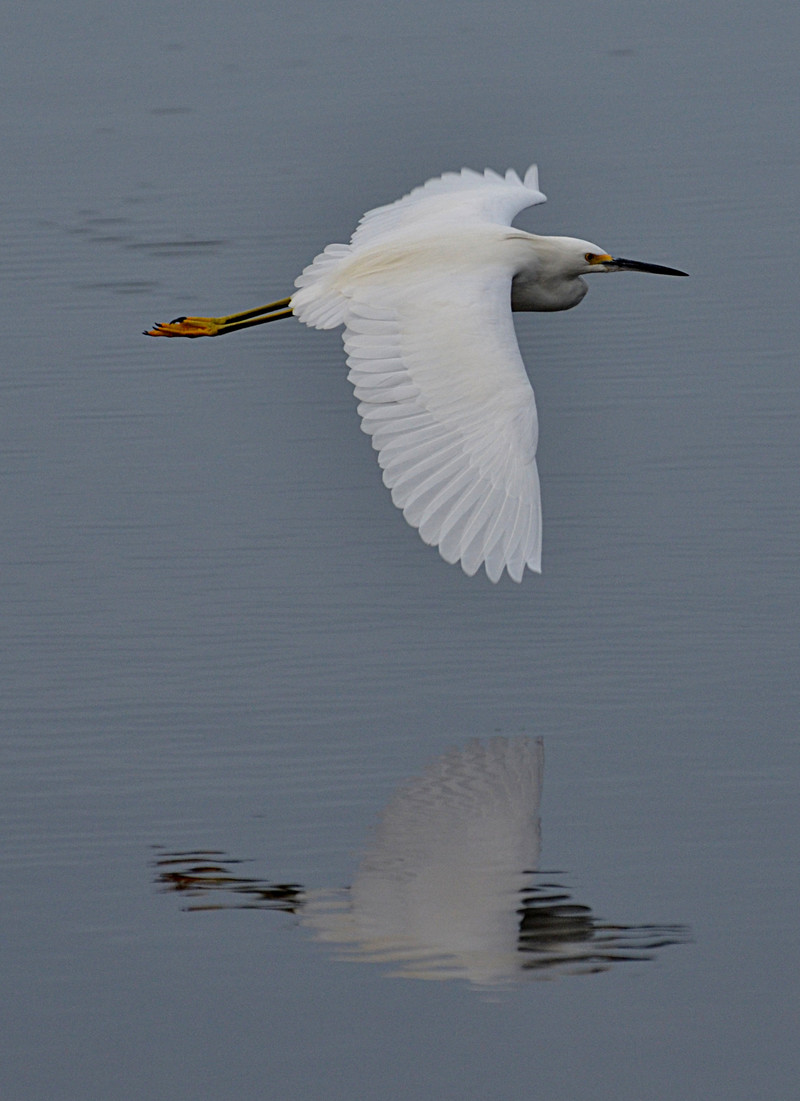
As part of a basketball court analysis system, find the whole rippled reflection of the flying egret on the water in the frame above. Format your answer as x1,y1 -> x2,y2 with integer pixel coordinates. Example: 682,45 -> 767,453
155,738 -> 689,986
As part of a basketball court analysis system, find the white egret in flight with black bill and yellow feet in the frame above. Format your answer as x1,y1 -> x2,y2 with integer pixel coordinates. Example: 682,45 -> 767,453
147,165 -> 687,581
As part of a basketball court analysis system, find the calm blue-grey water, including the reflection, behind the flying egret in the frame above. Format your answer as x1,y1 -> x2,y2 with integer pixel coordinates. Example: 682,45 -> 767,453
0,0 -> 800,1101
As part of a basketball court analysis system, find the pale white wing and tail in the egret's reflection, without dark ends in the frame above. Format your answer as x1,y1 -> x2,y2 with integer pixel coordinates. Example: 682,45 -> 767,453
302,738 -> 544,985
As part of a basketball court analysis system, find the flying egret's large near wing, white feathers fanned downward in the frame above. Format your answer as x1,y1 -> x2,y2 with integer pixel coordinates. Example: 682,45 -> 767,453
344,255 -> 541,581
